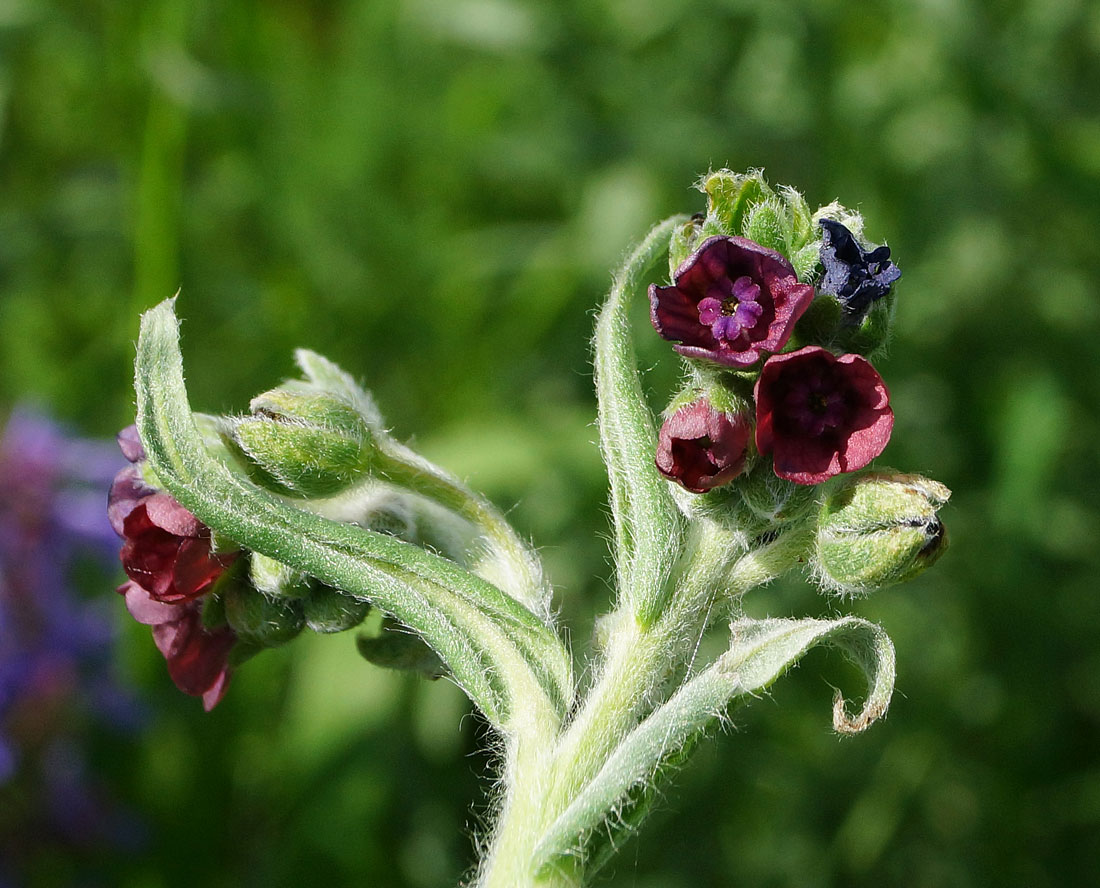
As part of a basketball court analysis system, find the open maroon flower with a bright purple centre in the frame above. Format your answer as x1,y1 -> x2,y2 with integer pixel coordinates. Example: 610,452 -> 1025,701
649,237 -> 814,366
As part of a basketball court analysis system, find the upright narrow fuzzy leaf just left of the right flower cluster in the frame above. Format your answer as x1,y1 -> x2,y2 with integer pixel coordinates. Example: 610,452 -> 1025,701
595,216 -> 685,625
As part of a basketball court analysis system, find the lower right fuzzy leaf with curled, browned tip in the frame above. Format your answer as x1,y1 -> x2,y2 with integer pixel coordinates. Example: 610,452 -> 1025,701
535,616 -> 894,875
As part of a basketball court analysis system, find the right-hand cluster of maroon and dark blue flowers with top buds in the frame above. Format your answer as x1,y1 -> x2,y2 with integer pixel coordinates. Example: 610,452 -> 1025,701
649,174 -> 901,493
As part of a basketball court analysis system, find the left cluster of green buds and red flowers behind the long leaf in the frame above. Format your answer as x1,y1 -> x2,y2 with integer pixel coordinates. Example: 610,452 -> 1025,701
108,351 -> 514,710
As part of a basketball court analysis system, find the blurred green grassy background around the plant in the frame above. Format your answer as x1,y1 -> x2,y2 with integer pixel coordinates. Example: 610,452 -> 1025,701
0,0 -> 1100,888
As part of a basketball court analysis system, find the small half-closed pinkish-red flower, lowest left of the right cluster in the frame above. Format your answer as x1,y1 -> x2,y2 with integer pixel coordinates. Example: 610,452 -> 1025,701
657,401 -> 750,493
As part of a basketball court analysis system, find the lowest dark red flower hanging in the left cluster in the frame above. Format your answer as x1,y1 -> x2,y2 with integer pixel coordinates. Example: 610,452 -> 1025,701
119,580 -> 237,712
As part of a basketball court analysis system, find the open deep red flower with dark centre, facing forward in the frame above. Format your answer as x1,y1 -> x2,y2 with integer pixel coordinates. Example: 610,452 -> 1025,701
756,346 -> 893,484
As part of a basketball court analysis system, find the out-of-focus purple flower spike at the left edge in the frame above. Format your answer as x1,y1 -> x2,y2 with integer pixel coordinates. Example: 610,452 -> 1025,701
0,409 -> 142,867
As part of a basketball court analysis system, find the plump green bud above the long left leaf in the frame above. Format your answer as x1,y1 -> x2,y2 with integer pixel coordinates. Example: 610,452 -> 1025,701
231,387 -> 375,497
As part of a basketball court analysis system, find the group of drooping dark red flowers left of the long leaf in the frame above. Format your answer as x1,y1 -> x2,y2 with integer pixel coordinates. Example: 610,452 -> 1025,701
107,426 -> 237,710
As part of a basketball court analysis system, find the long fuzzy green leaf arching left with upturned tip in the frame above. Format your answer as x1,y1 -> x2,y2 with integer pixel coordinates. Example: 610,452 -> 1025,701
135,299 -> 572,732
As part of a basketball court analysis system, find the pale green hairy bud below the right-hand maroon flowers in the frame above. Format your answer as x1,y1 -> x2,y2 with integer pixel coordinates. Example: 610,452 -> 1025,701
814,472 -> 950,595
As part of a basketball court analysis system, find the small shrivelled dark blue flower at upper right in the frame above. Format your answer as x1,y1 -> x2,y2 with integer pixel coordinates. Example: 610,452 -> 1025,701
818,219 -> 901,324
